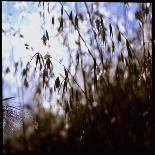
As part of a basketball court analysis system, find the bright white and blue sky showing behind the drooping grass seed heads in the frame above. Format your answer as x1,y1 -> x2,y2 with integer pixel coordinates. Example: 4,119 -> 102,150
2,1 -> 151,113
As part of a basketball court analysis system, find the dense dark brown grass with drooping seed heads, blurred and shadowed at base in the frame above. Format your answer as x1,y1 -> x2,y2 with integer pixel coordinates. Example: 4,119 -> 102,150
3,3 -> 152,152
